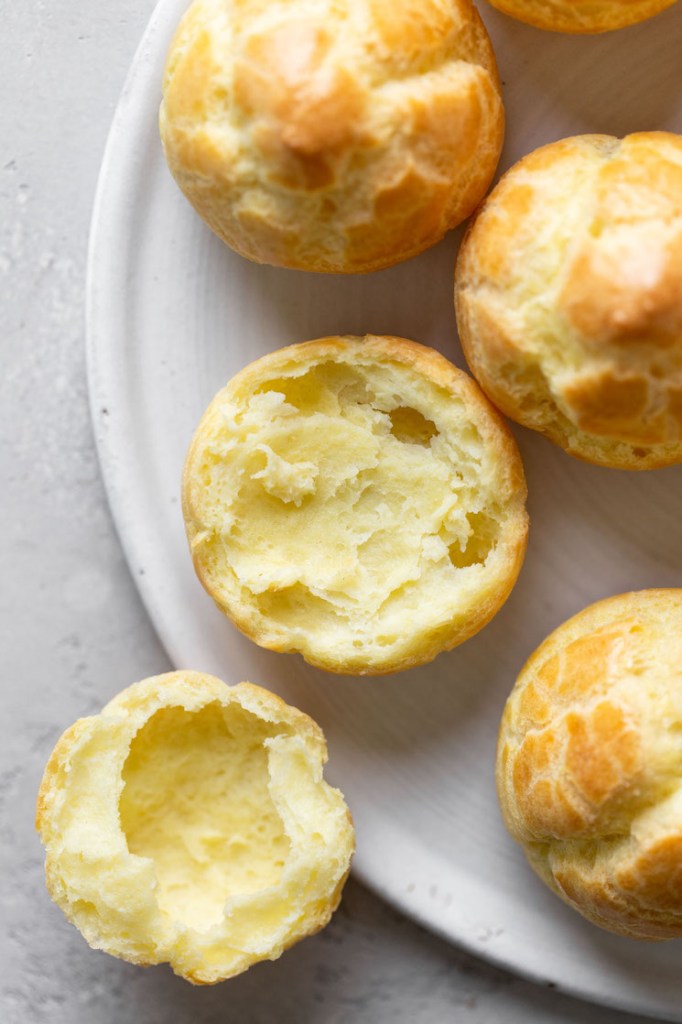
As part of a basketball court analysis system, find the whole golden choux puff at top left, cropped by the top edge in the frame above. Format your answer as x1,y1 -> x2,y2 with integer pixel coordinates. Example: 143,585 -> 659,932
160,0 -> 504,273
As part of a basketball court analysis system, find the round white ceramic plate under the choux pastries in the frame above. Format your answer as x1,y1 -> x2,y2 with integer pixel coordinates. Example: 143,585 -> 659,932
88,0 -> 682,1021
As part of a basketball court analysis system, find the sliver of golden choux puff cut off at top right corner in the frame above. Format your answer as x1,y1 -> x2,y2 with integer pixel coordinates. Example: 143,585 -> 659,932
491,0 -> 675,35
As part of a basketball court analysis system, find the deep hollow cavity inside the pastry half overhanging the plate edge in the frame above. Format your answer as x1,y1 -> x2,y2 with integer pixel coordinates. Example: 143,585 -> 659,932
119,701 -> 290,932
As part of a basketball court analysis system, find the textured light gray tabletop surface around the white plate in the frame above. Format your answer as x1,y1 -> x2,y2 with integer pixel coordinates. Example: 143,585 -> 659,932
0,0 -> 663,1024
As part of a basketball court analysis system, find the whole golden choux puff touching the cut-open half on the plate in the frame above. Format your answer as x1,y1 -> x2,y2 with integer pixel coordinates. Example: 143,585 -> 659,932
455,132 -> 682,469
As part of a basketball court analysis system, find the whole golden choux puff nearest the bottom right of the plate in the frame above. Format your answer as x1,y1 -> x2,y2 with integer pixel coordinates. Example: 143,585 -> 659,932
497,590 -> 682,939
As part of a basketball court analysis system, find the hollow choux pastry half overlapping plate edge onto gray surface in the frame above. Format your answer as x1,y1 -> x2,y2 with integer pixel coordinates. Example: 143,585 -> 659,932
36,672 -> 354,985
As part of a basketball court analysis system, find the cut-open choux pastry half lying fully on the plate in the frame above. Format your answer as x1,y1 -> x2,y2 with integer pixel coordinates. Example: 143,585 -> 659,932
182,336 -> 527,675
